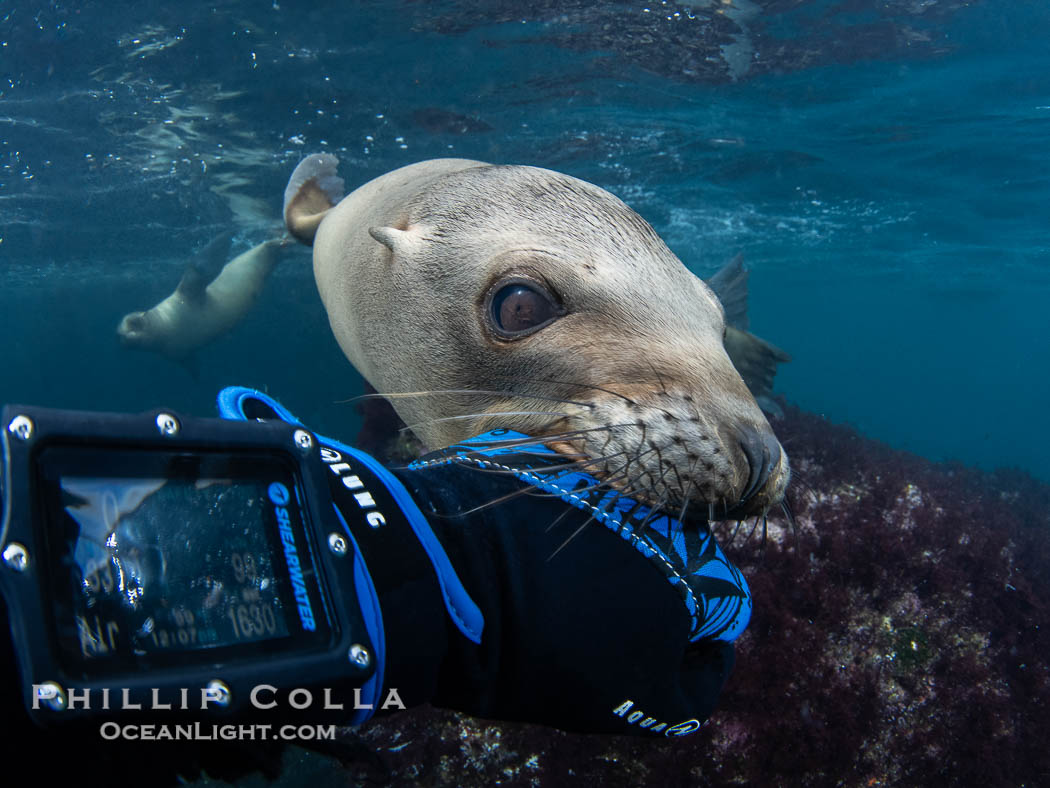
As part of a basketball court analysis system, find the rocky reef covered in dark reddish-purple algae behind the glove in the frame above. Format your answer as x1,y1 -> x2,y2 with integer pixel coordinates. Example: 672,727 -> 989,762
344,405 -> 1050,787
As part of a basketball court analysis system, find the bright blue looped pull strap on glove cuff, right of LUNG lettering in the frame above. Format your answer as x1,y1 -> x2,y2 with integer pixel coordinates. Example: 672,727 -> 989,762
218,386 -> 485,644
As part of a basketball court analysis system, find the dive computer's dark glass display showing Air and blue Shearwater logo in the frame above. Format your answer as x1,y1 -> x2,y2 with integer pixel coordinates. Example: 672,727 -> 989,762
38,447 -> 332,676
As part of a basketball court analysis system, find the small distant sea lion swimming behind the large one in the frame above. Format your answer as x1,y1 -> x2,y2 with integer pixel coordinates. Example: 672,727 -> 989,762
117,235 -> 289,361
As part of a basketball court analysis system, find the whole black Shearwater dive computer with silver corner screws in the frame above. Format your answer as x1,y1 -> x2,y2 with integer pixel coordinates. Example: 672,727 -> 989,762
0,406 -> 376,724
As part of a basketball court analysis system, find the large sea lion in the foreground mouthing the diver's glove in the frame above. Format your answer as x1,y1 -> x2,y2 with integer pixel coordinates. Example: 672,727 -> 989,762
285,154 -> 790,525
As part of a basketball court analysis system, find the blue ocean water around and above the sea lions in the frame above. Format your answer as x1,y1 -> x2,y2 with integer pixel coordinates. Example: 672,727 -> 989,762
0,0 -> 1050,479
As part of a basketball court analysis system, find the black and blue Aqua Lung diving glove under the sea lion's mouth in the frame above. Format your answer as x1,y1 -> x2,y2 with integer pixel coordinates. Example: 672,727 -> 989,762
221,390 -> 751,735
